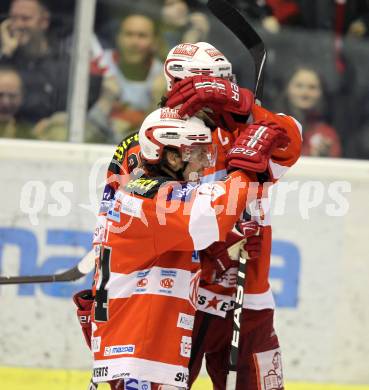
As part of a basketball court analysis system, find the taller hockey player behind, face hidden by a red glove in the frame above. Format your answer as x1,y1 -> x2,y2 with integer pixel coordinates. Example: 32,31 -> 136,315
164,43 -> 302,390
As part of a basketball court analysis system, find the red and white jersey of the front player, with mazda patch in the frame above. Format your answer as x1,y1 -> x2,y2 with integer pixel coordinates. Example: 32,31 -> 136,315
91,171 -> 256,387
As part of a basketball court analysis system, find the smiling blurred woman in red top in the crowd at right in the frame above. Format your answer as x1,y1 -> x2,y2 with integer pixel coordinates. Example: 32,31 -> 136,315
275,66 -> 341,157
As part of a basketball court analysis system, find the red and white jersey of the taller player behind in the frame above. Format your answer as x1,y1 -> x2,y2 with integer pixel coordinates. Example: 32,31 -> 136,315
198,104 -> 302,317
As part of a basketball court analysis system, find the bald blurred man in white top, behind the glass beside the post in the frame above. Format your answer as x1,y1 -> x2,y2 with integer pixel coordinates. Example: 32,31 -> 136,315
95,14 -> 165,142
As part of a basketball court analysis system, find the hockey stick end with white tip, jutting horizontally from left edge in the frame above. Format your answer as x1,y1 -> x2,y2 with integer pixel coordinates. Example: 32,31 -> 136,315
0,250 -> 95,285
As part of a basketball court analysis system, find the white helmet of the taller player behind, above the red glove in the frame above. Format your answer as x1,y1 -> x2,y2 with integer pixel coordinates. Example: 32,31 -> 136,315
164,42 -> 234,91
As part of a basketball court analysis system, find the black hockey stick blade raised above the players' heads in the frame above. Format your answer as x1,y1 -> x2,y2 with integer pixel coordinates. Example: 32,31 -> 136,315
207,0 -> 267,102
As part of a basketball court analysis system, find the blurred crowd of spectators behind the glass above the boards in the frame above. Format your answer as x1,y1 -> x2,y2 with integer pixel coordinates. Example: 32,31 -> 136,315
0,0 -> 369,159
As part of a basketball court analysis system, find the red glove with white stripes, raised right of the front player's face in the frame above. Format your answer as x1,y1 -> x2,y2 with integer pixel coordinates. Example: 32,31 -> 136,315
227,121 -> 290,172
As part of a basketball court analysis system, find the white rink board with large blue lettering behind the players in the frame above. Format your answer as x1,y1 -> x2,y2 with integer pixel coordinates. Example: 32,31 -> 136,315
0,140 -> 369,383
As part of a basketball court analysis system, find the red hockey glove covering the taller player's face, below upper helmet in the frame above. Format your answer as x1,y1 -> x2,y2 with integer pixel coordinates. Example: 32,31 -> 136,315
166,75 -> 254,116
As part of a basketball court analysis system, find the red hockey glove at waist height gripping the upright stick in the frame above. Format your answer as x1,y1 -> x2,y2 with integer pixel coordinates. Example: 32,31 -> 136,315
200,221 -> 261,283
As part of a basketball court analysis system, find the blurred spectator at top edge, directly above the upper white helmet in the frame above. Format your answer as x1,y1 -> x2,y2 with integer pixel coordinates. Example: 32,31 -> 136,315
160,0 -> 210,58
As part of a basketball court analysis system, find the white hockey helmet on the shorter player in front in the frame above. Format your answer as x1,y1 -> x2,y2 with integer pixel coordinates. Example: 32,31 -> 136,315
138,107 -> 216,166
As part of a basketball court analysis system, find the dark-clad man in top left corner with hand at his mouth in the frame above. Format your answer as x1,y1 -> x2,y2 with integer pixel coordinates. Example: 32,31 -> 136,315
0,0 -> 69,123
